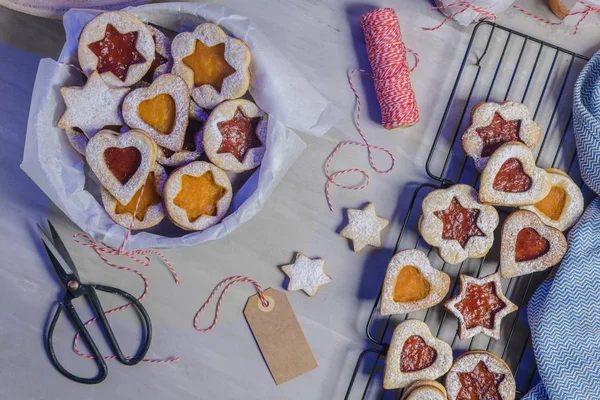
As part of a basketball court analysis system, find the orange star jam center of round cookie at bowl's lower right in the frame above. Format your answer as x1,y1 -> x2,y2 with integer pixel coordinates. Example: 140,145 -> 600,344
173,171 -> 227,222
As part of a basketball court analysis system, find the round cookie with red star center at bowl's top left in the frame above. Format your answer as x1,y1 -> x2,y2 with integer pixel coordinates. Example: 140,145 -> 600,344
77,11 -> 155,86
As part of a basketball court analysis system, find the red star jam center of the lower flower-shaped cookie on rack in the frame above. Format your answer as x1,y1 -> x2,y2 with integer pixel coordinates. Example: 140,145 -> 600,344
433,197 -> 485,249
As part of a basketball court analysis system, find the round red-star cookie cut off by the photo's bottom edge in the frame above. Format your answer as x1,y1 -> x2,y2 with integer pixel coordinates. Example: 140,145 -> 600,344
445,350 -> 516,400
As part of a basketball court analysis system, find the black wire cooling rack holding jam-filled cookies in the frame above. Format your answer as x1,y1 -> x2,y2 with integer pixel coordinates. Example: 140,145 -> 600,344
345,22 -> 592,399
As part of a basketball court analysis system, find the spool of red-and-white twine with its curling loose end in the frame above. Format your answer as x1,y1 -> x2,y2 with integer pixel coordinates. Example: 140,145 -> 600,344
325,8 -> 419,211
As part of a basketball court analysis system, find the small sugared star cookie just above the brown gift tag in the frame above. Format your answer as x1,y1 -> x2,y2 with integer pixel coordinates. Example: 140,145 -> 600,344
281,252 -> 332,297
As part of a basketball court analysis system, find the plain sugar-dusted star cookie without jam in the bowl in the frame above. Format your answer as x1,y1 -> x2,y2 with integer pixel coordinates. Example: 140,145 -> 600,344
56,71 -> 131,138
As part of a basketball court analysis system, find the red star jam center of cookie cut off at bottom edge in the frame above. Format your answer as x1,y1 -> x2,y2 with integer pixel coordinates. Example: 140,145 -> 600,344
456,361 -> 506,400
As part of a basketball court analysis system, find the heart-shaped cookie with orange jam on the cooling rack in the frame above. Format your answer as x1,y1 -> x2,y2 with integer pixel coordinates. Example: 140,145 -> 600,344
380,250 -> 450,315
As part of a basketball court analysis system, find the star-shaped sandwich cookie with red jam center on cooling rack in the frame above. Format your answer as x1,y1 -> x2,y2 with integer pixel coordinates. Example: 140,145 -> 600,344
444,273 -> 518,340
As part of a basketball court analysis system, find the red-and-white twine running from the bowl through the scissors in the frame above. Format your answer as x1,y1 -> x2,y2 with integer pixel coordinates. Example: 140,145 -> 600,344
73,184 -> 180,363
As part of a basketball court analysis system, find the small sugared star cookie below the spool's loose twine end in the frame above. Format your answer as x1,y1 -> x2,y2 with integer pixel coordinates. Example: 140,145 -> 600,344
340,203 -> 389,252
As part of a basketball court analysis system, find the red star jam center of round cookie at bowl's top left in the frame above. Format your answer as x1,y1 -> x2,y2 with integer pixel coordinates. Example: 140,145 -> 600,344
88,24 -> 146,82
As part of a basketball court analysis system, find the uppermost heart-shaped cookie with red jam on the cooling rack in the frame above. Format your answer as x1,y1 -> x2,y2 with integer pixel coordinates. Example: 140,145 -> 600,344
479,142 -> 551,206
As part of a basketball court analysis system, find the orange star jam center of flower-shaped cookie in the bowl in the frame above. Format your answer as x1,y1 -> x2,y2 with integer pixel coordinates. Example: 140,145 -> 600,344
182,40 -> 235,92
